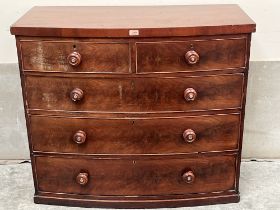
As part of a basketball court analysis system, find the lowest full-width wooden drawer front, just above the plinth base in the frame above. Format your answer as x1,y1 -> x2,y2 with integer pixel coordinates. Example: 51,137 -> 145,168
35,155 -> 236,196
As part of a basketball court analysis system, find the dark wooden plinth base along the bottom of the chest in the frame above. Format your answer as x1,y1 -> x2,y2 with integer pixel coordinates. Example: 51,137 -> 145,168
34,193 -> 240,209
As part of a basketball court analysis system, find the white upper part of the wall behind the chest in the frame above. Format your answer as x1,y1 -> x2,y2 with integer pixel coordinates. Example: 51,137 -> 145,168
0,0 -> 280,63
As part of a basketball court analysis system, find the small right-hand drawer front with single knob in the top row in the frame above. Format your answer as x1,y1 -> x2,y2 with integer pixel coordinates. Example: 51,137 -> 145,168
136,38 -> 247,73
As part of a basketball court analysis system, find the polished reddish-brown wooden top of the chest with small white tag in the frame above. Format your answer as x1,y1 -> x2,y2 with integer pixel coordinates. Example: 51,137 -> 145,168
11,5 -> 256,37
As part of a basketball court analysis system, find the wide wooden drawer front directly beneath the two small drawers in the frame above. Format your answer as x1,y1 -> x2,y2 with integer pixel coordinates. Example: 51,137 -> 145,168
26,74 -> 243,112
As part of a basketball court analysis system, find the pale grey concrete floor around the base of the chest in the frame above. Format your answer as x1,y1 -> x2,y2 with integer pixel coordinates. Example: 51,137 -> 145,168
0,160 -> 280,210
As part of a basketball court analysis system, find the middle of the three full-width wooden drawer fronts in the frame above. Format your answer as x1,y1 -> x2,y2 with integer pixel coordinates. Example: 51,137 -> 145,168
30,114 -> 240,154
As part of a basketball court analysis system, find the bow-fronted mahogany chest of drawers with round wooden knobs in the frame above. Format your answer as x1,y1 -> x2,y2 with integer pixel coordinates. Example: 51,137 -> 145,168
11,5 -> 255,208
